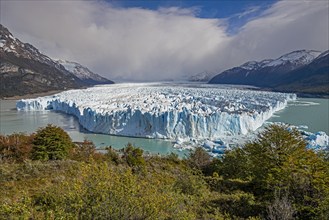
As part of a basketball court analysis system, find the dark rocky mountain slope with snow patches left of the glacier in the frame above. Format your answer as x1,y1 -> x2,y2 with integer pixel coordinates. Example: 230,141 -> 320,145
0,24 -> 113,98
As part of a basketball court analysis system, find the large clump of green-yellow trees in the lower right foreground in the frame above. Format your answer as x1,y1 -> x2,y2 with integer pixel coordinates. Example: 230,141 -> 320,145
220,125 -> 329,219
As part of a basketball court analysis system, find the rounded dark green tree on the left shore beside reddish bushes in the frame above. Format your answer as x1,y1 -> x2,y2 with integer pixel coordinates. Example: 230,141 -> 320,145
32,124 -> 74,160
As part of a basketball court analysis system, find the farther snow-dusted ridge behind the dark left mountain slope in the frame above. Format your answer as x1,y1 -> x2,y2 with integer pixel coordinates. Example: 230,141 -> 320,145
57,60 -> 113,84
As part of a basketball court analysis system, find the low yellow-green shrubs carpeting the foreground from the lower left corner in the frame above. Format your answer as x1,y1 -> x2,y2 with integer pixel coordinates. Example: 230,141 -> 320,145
0,156 -> 212,219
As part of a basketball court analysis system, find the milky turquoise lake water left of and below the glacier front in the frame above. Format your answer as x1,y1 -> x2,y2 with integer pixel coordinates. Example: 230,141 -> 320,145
0,100 -> 187,156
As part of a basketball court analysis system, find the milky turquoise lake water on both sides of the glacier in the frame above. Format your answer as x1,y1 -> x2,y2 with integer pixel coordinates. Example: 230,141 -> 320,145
0,98 -> 329,156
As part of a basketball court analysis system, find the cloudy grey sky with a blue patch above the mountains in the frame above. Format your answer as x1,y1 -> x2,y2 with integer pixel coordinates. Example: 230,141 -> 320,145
0,0 -> 329,81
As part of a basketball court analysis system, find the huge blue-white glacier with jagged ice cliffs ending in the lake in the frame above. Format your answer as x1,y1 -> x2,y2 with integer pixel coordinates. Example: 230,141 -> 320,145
16,83 -> 296,140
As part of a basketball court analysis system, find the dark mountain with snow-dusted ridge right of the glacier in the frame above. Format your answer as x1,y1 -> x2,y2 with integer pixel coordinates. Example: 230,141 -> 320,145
209,50 -> 329,96
